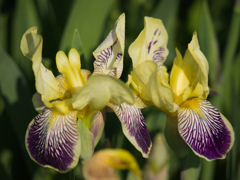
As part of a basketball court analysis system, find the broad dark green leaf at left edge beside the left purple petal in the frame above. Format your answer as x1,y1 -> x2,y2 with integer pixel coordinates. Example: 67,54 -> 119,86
0,48 -> 35,172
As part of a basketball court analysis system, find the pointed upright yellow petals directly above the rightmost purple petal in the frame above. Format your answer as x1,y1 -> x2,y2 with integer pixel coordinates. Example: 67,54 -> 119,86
170,33 -> 209,104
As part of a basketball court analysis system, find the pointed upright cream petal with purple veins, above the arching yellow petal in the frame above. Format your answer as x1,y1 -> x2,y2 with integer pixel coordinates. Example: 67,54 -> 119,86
93,13 -> 125,78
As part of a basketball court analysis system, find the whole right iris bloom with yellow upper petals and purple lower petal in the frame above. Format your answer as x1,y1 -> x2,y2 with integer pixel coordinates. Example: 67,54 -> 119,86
129,17 -> 234,160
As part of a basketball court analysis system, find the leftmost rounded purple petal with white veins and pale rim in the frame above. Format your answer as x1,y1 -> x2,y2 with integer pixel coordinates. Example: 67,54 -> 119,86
26,108 -> 81,172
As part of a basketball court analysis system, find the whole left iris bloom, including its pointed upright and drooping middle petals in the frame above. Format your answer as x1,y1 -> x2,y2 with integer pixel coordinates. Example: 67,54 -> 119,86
21,14 -> 151,172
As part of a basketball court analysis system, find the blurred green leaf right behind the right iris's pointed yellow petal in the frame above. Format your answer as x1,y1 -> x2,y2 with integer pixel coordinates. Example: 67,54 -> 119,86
198,1 -> 220,90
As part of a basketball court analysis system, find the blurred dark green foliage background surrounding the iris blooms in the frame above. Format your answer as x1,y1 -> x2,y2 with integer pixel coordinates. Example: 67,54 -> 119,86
0,0 -> 240,180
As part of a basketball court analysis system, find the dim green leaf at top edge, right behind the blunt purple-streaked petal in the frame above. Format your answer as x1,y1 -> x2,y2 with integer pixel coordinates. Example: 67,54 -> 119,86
151,0 -> 179,66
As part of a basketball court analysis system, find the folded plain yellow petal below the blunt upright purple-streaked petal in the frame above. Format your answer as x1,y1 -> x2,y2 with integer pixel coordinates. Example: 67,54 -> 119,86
132,61 -> 178,112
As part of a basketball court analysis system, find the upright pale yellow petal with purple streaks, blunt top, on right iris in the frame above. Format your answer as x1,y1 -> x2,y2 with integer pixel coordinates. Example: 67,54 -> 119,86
129,17 -> 168,68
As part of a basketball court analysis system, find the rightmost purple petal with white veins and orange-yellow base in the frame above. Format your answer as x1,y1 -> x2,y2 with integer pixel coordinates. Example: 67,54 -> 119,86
178,98 -> 234,161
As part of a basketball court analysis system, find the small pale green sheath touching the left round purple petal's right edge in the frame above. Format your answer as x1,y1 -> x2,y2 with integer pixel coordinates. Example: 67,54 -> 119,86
77,119 -> 94,160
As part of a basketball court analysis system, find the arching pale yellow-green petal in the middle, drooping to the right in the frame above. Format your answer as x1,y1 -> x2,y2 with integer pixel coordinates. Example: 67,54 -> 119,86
72,75 -> 134,111
